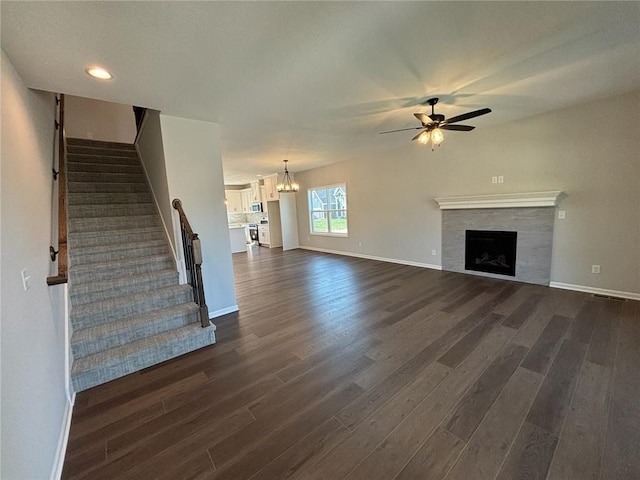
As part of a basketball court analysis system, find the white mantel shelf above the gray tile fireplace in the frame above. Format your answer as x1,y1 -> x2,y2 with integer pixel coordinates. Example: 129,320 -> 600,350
435,191 -> 564,210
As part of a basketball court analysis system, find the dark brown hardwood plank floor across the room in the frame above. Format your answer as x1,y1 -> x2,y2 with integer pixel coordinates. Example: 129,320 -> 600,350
63,247 -> 640,480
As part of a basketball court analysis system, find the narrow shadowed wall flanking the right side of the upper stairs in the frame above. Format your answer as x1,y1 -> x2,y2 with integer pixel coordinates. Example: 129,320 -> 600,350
136,110 -> 176,252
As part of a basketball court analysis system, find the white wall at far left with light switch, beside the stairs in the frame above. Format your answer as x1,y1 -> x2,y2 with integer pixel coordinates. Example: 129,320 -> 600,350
0,50 -> 70,480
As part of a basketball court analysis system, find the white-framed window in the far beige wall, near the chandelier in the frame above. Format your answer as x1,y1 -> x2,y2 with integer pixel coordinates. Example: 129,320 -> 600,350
308,183 -> 348,237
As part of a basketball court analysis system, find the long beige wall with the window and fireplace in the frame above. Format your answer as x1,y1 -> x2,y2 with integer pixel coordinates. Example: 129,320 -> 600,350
296,88 -> 640,294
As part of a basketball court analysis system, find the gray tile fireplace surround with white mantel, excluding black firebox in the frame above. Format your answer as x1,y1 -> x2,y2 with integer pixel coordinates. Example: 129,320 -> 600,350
435,191 -> 563,285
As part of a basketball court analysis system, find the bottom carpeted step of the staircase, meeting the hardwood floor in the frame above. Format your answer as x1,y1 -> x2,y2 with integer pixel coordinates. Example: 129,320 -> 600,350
71,323 -> 215,391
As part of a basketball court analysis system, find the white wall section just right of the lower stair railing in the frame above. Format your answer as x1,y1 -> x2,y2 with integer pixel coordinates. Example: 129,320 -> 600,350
160,114 -> 238,318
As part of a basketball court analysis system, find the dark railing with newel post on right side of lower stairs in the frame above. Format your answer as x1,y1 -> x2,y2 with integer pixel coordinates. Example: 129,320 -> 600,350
171,198 -> 210,328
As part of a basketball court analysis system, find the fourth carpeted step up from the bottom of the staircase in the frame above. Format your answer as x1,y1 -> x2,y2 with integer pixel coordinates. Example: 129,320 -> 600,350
69,269 -> 179,306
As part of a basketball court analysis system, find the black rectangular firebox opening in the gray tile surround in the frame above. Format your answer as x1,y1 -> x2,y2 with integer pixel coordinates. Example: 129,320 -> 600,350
464,230 -> 518,277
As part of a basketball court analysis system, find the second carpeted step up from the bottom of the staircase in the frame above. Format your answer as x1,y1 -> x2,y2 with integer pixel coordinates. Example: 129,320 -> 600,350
71,303 -> 200,359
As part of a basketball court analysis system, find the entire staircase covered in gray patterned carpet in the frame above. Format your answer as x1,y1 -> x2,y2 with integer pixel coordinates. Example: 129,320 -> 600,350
67,138 -> 215,392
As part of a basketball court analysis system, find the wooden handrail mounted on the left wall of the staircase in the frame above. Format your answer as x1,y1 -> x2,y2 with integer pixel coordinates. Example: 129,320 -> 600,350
47,94 -> 68,285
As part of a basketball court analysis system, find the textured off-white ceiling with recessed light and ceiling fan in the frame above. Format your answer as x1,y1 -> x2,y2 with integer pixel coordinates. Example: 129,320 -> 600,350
0,0 -> 640,183
